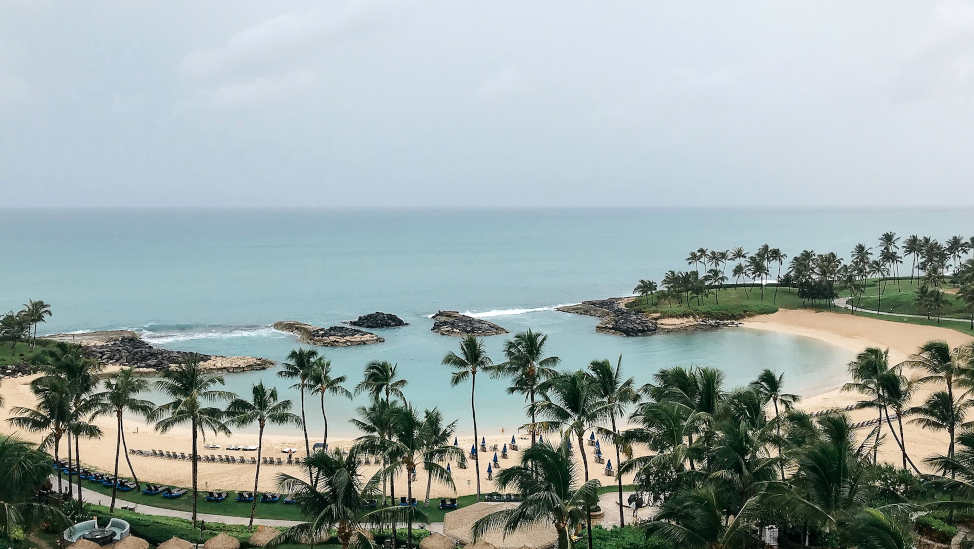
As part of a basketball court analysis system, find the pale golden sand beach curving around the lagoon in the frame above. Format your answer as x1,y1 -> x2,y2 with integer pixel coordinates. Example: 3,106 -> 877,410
0,310 -> 972,498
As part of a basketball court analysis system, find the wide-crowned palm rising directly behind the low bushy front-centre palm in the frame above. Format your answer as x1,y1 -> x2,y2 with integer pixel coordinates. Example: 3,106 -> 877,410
532,370 -> 613,549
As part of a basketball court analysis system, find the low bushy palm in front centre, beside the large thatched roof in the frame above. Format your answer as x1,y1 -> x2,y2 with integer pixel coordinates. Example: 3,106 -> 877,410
473,443 -> 599,549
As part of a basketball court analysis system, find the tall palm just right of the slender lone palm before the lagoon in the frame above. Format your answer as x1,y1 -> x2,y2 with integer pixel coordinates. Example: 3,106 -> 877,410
494,329 -> 561,445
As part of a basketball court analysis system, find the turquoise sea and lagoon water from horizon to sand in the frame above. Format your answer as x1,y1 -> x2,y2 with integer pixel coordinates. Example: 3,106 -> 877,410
0,209 -> 974,435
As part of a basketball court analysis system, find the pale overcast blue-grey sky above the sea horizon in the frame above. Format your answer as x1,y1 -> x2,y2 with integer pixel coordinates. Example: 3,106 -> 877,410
0,0 -> 974,208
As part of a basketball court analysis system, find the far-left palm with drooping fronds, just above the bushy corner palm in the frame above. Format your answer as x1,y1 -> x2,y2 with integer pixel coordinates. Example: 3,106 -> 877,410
7,378 -> 71,495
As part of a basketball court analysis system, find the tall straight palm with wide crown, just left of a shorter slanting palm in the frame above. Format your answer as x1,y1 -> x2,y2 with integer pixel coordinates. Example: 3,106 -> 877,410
149,360 -> 236,523
